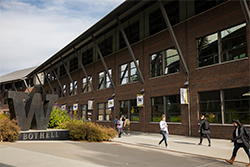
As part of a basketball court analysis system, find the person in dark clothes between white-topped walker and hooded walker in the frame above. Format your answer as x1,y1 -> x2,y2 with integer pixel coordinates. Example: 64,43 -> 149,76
198,115 -> 211,147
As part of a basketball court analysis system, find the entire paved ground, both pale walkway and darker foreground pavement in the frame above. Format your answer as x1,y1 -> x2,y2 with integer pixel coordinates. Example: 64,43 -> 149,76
0,132 -> 248,167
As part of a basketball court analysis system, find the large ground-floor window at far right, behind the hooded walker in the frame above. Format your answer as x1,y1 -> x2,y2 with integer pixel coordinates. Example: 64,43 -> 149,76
199,87 -> 250,124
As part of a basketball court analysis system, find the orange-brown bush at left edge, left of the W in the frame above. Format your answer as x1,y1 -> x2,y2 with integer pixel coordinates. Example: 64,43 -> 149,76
0,116 -> 20,142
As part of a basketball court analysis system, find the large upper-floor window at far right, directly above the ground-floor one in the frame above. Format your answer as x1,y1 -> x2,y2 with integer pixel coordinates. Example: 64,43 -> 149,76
197,23 -> 247,67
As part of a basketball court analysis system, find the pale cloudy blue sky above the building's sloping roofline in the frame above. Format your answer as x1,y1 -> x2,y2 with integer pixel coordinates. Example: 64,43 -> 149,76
0,0 -> 124,76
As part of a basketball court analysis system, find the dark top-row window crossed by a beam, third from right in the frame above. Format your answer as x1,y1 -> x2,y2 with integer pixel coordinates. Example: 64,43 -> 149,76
119,21 -> 140,49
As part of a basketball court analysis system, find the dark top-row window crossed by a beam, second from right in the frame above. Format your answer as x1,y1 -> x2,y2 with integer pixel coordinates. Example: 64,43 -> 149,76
149,0 -> 179,35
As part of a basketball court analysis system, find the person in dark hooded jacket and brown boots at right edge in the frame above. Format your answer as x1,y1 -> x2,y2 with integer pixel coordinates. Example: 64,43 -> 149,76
226,119 -> 250,166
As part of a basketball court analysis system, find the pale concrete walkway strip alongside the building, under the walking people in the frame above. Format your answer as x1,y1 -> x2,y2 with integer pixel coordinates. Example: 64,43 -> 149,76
113,132 -> 249,163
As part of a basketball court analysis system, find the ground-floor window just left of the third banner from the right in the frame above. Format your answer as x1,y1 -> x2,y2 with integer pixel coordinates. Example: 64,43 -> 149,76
97,103 -> 111,121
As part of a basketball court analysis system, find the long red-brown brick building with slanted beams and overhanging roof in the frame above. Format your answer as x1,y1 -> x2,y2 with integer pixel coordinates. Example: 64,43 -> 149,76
8,0 -> 250,138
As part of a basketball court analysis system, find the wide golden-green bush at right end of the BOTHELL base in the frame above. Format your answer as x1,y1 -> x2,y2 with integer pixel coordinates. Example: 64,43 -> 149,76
60,120 -> 117,142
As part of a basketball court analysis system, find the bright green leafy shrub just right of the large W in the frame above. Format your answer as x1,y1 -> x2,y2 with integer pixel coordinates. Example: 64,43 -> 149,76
48,106 -> 71,128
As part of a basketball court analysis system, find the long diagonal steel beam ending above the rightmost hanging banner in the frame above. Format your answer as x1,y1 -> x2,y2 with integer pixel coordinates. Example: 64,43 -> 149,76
158,0 -> 189,76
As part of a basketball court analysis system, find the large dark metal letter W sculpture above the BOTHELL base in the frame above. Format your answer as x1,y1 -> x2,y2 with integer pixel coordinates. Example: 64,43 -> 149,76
7,91 -> 58,131
